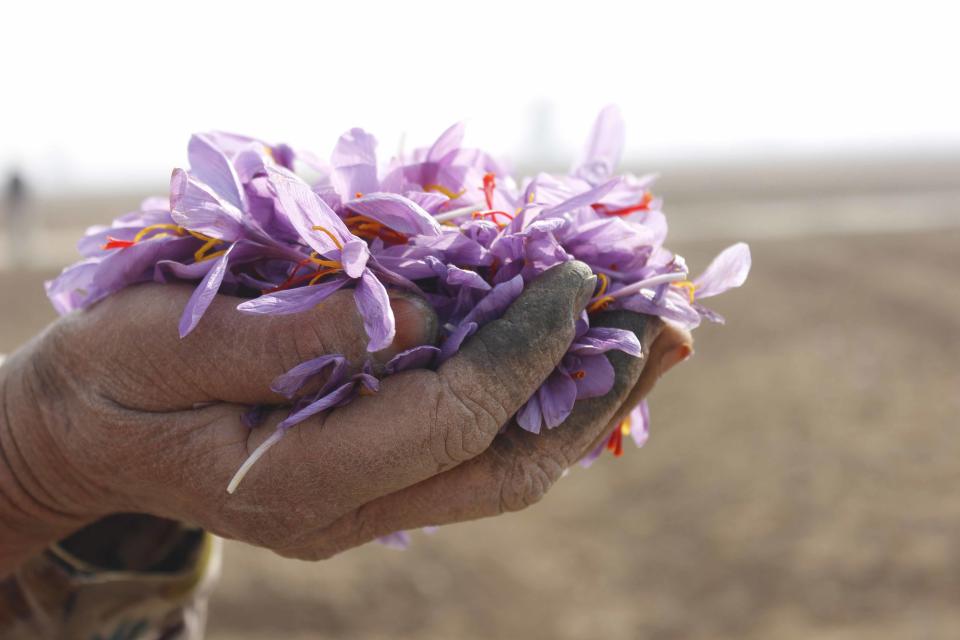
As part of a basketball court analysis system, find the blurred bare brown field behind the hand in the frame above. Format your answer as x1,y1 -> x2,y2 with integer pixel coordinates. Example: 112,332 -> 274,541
0,180 -> 960,640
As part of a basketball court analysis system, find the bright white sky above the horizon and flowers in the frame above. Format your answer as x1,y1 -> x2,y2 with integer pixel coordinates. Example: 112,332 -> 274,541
0,0 -> 960,190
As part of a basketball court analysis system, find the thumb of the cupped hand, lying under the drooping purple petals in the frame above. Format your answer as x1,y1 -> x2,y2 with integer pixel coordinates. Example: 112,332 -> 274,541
67,284 -> 437,411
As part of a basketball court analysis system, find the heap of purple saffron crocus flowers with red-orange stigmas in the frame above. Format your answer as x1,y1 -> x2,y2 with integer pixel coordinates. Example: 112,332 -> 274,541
47,107 -> 750,492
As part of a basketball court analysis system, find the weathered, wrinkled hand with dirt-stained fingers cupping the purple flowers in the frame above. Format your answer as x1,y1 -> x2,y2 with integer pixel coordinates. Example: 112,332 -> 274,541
0,262 -> 691,575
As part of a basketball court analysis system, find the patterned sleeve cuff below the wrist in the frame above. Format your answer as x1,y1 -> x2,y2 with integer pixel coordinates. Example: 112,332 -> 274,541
0,514 -> 221,640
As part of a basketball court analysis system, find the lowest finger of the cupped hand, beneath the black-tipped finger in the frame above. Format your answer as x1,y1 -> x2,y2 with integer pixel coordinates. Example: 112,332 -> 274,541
281,312 -> 684,558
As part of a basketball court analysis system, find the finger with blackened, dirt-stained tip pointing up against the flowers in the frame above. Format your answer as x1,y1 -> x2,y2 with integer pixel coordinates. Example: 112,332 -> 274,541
224,262 -> 595,513
